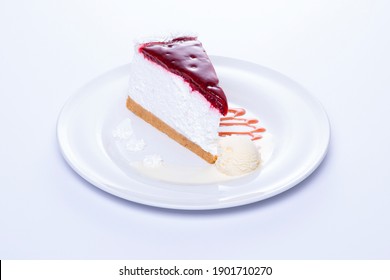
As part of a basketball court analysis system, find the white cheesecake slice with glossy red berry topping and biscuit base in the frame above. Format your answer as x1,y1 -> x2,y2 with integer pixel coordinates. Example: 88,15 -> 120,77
126,37 -> 228,163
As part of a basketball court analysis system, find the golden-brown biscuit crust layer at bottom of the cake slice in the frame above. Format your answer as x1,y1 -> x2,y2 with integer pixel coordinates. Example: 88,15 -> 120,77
126,96 -> 217,163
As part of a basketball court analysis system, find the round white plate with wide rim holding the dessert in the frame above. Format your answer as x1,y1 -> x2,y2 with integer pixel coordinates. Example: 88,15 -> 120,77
57,56 -> 330,210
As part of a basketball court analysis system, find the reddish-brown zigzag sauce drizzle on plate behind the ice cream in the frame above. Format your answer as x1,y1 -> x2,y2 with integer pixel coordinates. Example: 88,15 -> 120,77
219,108 -> 265,141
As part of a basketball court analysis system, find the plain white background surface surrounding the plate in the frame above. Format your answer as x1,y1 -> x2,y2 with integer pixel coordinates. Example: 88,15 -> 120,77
0,0 -> 390,259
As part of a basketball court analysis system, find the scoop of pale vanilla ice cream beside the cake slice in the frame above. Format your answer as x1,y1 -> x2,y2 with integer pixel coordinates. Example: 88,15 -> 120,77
215,136 -> 261,176
